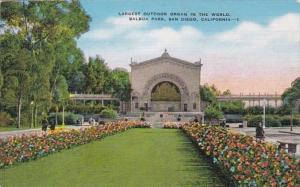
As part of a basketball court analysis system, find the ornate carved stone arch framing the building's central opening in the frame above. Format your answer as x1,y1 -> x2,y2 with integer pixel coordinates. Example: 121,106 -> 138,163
143,73 -> 189,111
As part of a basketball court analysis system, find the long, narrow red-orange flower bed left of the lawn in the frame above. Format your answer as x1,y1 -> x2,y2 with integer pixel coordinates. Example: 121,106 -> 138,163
0,121 -> 149,168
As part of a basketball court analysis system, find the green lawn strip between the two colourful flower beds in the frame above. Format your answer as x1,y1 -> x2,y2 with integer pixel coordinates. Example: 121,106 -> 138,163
0,129 -> 224,187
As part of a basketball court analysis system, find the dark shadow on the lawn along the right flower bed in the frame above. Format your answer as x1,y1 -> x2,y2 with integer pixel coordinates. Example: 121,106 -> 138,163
177,131 -> 235,187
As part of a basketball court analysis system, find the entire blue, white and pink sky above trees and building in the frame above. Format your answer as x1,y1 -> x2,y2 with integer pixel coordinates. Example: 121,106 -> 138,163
78,0 -> 300,94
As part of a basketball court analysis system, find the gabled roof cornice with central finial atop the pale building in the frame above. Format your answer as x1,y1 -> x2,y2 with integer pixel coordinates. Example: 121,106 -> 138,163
130,49 -> 202,67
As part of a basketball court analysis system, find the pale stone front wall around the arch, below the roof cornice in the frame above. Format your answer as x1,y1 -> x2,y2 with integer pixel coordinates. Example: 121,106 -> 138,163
130,54 -> 201,112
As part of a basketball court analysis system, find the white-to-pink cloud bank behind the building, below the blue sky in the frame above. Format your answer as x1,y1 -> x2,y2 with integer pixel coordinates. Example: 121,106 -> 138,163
79,14 -> 300,93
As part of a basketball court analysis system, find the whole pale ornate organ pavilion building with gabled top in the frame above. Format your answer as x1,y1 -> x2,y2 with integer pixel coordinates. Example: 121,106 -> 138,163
130,50 -> 202,112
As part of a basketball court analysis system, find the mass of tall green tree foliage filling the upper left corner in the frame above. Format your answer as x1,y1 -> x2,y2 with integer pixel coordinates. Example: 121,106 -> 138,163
0,1 -> 90,128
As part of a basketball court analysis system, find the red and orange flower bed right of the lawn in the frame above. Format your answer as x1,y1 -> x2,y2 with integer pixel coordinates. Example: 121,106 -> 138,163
181,124 -> 300,187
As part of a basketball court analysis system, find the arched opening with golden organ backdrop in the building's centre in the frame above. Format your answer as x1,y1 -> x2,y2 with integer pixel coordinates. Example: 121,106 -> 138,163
151,81 -> 181,112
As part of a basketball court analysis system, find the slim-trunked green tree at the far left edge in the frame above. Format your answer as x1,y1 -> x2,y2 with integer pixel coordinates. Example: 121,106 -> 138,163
0,33 -> 32,128
